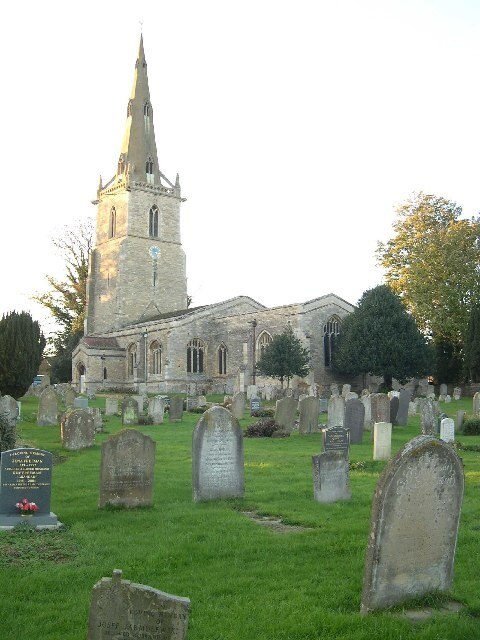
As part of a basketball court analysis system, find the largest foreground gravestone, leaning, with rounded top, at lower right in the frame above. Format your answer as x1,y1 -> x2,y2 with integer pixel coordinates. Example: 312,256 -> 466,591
361,436 -> 464,613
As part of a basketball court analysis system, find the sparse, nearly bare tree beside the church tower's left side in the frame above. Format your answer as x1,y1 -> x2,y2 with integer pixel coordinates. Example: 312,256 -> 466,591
33,219 -> 93,382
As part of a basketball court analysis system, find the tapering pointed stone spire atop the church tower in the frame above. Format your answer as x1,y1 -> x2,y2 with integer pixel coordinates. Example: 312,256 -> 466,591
117,34 -> 160,185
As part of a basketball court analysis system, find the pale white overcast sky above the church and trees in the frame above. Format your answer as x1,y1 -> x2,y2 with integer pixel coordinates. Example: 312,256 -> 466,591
0,0 -> 480,333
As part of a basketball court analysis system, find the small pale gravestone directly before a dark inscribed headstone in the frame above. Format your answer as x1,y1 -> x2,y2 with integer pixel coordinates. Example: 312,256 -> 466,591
312,451 -> 351,502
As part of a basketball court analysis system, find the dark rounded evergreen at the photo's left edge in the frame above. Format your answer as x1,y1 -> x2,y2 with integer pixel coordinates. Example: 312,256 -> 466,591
0,311 -> 45,398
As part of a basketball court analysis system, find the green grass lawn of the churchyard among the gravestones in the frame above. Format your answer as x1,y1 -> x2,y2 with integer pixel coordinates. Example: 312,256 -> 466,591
0,398 -> 480,640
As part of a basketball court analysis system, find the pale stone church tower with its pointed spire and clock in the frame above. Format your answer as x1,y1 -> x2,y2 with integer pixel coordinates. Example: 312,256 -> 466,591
85,37 -> 187,335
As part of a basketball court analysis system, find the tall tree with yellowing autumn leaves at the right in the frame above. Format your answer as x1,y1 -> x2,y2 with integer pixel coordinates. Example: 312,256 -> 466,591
377,192 -> 480,353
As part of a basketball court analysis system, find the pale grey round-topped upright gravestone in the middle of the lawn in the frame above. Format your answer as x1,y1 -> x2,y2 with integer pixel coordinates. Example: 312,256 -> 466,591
192,407 -> 244,502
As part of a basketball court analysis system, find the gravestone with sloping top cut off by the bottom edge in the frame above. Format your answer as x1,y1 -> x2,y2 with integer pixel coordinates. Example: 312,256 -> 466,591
87,569 -> 190,640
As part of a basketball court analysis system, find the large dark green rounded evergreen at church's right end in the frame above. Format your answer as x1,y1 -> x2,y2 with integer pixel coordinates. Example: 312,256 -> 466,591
333,285 -> 431,389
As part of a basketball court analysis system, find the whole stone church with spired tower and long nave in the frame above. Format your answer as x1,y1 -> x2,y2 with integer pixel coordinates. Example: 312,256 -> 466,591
72,37 -> 354,394
